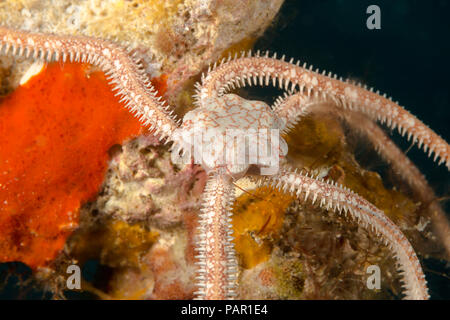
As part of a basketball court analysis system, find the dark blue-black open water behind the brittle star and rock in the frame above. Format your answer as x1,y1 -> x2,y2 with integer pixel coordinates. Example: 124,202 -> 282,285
0,0 -> 450,299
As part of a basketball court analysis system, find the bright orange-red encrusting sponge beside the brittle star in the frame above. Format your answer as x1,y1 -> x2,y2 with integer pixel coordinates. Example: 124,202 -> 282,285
0,63 -> 146,268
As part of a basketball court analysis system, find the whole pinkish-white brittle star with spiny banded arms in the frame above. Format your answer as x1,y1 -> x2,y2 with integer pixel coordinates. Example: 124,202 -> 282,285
0,27 -> 450,299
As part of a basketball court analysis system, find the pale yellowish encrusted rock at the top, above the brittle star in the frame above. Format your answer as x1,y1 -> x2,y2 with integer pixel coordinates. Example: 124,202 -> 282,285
0,0 -> 283,97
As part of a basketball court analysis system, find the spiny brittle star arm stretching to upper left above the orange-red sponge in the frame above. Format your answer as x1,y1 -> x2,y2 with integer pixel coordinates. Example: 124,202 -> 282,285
0,26 -> 178,139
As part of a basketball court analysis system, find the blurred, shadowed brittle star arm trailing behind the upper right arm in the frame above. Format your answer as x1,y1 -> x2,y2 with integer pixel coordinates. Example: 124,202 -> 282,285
273,93 -> 450,257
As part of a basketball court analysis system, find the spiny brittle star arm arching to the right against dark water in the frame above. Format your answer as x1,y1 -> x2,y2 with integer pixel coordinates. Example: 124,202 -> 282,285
196,52 -> 450,170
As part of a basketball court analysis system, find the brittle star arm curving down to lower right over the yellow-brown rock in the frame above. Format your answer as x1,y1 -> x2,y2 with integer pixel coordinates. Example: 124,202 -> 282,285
259,171 -> 429,300
